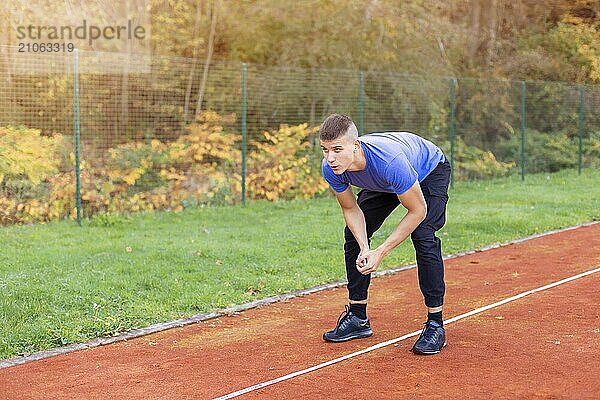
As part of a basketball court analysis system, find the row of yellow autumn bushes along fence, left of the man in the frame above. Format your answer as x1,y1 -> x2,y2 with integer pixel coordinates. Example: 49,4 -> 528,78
0,112 -> 327,225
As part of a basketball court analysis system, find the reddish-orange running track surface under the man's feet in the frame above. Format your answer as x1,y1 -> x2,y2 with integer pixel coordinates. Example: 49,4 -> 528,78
0,224 -> 600,399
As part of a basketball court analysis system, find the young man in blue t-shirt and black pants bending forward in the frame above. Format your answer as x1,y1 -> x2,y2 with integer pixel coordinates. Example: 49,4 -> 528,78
320,114 -> 450,354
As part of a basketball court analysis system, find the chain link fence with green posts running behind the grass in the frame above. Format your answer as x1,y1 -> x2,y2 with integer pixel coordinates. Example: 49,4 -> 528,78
0,46 -> 600,224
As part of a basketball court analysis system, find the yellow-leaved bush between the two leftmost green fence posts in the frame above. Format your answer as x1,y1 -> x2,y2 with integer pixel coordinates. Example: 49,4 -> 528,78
82,112 -> 241,215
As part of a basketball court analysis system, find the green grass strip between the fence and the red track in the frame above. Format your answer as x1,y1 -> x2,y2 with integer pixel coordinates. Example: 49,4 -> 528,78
0,170 -> 600,359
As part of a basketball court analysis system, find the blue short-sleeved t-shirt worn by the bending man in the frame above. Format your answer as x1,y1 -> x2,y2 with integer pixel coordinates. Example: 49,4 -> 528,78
322,132 -> 445,194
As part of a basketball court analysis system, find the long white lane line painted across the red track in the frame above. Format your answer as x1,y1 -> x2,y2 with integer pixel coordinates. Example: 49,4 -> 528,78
214,268 -> 600,400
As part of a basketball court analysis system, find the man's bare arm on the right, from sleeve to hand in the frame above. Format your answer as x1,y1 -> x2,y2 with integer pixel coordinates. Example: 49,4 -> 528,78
356,181 -> 427,275
